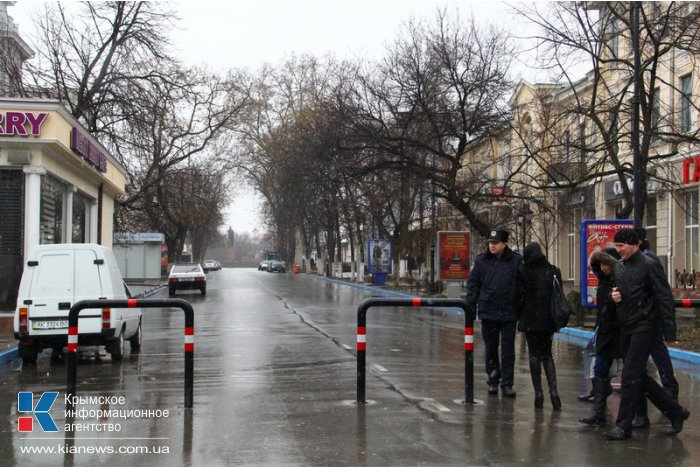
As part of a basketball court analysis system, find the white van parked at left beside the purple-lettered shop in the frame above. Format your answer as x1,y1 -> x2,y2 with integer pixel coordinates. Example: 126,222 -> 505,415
14,243 -> 142,363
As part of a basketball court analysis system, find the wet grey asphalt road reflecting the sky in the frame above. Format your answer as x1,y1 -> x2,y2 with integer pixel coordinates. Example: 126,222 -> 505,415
0,269 -> 700,466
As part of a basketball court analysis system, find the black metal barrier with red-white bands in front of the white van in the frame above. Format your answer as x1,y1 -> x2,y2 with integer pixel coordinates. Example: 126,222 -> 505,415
66,298 -> 194,410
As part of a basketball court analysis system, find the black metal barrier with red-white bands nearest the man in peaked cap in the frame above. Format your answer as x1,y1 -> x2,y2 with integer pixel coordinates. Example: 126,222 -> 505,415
357,298 -> 474,404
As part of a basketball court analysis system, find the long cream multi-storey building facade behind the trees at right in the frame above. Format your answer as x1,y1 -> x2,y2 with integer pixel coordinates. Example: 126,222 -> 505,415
469,3 -> 700,296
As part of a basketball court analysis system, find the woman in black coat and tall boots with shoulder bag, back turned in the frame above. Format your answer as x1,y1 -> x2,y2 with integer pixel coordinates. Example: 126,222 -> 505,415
514,243 -> 561,410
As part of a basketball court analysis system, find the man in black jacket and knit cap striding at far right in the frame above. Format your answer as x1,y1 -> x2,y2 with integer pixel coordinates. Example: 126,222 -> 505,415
605,229 -> 690,441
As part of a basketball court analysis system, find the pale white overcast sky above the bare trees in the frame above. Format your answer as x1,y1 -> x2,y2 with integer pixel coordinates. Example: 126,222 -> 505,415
8,0 -> 548,232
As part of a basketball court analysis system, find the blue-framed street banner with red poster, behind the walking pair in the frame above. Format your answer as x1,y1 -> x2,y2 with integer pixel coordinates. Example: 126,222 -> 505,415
581,219 -> 634,308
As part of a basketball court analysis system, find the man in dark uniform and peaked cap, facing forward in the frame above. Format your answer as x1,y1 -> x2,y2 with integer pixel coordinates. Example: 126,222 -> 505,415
467,229 -> 523,397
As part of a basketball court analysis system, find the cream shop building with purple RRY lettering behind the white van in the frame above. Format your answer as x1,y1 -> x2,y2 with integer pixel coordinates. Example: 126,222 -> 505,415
0,98 -> 127,308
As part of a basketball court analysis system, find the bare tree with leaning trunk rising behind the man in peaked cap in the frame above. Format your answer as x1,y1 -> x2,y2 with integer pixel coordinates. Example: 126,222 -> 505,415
354,10 -> 512,238
